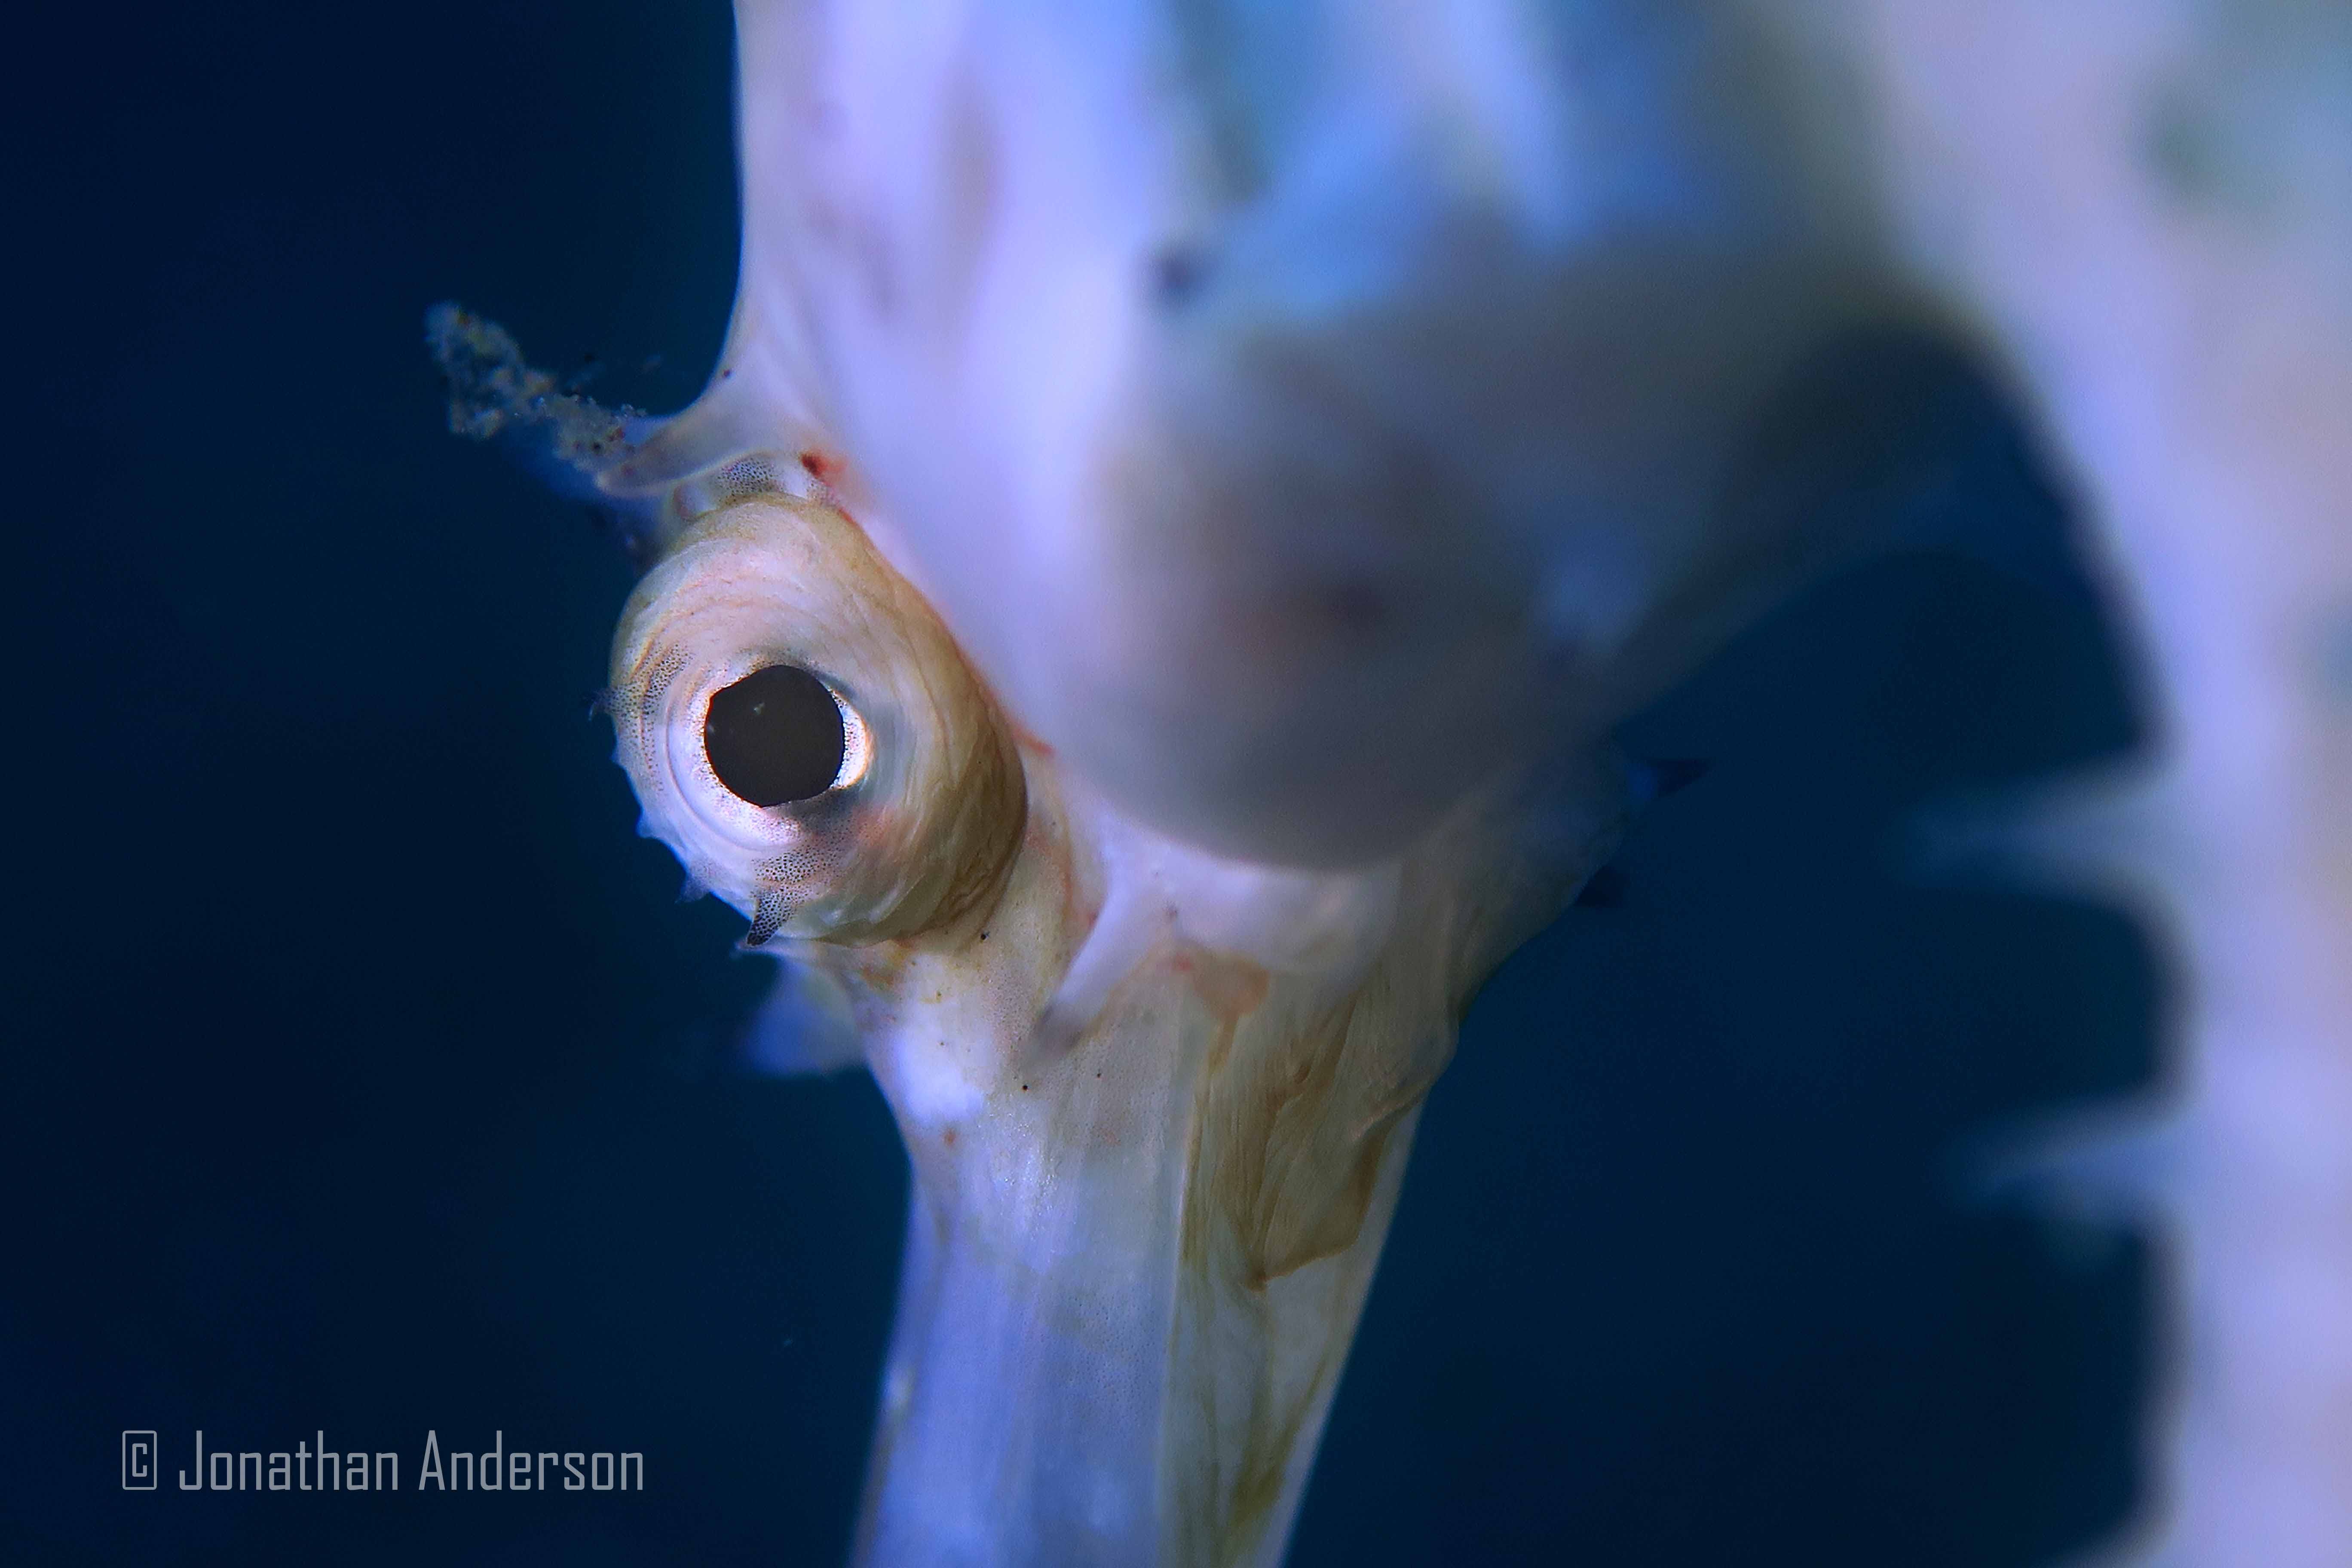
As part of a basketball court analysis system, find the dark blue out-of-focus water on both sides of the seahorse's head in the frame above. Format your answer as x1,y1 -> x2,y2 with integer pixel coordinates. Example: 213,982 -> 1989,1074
0,0 -> 2162,1568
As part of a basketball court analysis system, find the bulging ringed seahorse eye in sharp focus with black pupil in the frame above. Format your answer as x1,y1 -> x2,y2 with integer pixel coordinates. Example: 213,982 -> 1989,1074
604,494 -> 1028,947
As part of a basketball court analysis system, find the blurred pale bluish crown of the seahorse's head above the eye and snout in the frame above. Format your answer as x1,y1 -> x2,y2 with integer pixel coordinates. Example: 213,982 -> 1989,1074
614,0 -> 1914,867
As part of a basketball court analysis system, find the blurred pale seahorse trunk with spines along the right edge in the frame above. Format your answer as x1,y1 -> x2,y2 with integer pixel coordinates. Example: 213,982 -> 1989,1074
1877,0 -> 2352,1568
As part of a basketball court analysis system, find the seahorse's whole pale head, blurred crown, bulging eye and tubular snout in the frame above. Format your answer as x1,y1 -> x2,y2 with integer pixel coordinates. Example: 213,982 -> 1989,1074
435,0 -> 1900,1568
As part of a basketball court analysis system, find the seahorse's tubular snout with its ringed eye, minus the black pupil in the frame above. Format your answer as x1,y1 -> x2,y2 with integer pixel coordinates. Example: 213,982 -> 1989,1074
607,491 -> 1630,1563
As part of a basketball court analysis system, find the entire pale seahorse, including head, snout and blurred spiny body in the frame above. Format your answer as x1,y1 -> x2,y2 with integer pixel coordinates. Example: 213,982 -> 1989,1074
428,0 -> 2352,1566
